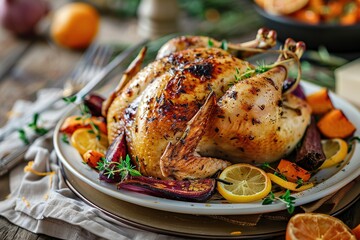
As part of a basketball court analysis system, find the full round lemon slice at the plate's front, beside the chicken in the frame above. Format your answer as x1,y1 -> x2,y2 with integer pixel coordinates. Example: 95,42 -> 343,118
217,163 -> 271,202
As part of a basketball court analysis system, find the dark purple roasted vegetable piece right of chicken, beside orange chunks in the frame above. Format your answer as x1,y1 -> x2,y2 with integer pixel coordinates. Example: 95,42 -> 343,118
295,117 -> 326,171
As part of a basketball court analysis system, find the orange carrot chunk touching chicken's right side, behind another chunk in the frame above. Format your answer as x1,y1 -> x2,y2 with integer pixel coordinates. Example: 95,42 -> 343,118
306,88 -> 334,114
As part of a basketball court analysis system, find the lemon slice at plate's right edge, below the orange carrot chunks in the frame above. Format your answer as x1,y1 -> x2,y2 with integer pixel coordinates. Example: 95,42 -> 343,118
319,138 -> 348,169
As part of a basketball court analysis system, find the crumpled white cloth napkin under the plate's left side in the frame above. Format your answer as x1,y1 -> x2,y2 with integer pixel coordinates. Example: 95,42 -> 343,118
0,89 -> 179,240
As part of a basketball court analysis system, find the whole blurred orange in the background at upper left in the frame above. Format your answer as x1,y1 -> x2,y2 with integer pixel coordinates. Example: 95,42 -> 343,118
50,2 -> 100,48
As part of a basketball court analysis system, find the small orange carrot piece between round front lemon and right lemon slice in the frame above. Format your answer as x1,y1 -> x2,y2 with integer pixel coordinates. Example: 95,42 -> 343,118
277,159 -> 311,182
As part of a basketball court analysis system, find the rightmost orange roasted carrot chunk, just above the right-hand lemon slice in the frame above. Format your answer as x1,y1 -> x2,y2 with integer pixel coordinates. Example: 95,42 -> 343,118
317,109 -> 356,138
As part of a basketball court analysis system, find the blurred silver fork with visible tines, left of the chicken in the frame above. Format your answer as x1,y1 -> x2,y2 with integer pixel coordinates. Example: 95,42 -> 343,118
0,44 -> 114,141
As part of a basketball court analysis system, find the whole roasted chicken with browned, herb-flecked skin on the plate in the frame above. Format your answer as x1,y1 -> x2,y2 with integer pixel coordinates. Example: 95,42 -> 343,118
103,29 -> 311,179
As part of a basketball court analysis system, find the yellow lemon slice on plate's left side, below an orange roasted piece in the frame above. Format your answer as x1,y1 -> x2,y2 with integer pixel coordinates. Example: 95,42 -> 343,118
71,128 -> 109,155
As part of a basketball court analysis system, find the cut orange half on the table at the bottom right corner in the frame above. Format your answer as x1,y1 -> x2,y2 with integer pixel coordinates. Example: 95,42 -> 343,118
286,213 -> 356,240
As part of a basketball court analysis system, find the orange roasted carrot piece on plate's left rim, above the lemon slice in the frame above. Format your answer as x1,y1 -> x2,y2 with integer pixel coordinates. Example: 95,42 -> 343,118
60,116 -> 107,134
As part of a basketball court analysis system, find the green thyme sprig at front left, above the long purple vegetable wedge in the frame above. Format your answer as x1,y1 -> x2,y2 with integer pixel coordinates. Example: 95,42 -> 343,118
96,155 -> 141,181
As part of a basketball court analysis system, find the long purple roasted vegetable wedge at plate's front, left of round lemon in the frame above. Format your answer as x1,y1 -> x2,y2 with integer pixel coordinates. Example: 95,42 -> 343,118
118,177 -> 216,202
